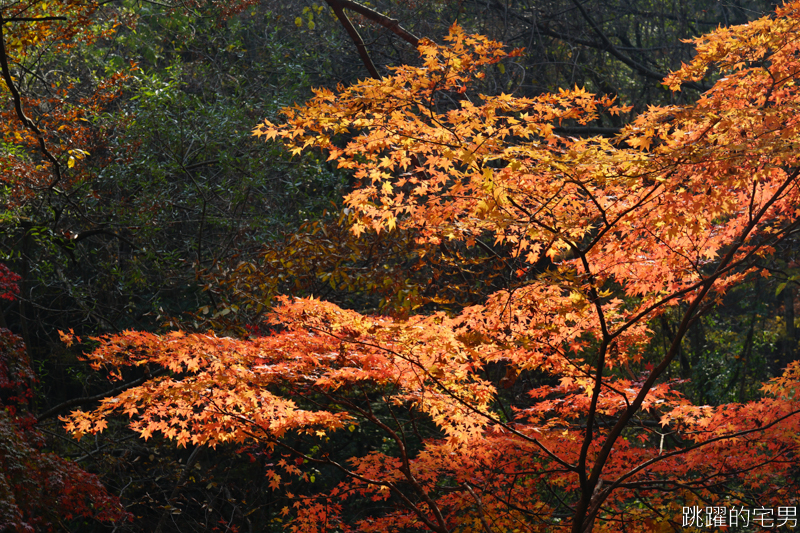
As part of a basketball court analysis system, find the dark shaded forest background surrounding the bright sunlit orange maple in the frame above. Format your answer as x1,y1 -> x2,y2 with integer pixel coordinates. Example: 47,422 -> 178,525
0,0 -> 800,531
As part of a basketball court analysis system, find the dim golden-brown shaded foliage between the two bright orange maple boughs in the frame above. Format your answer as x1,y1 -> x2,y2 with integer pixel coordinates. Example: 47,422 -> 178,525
199,204 -> 513,336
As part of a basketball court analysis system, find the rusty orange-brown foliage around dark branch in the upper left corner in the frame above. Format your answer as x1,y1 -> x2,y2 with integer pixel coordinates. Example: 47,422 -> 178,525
0,1 -> 123,206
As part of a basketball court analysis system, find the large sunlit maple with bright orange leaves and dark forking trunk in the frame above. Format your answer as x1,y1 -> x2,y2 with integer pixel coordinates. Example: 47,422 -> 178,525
59,2 -> 800,533
